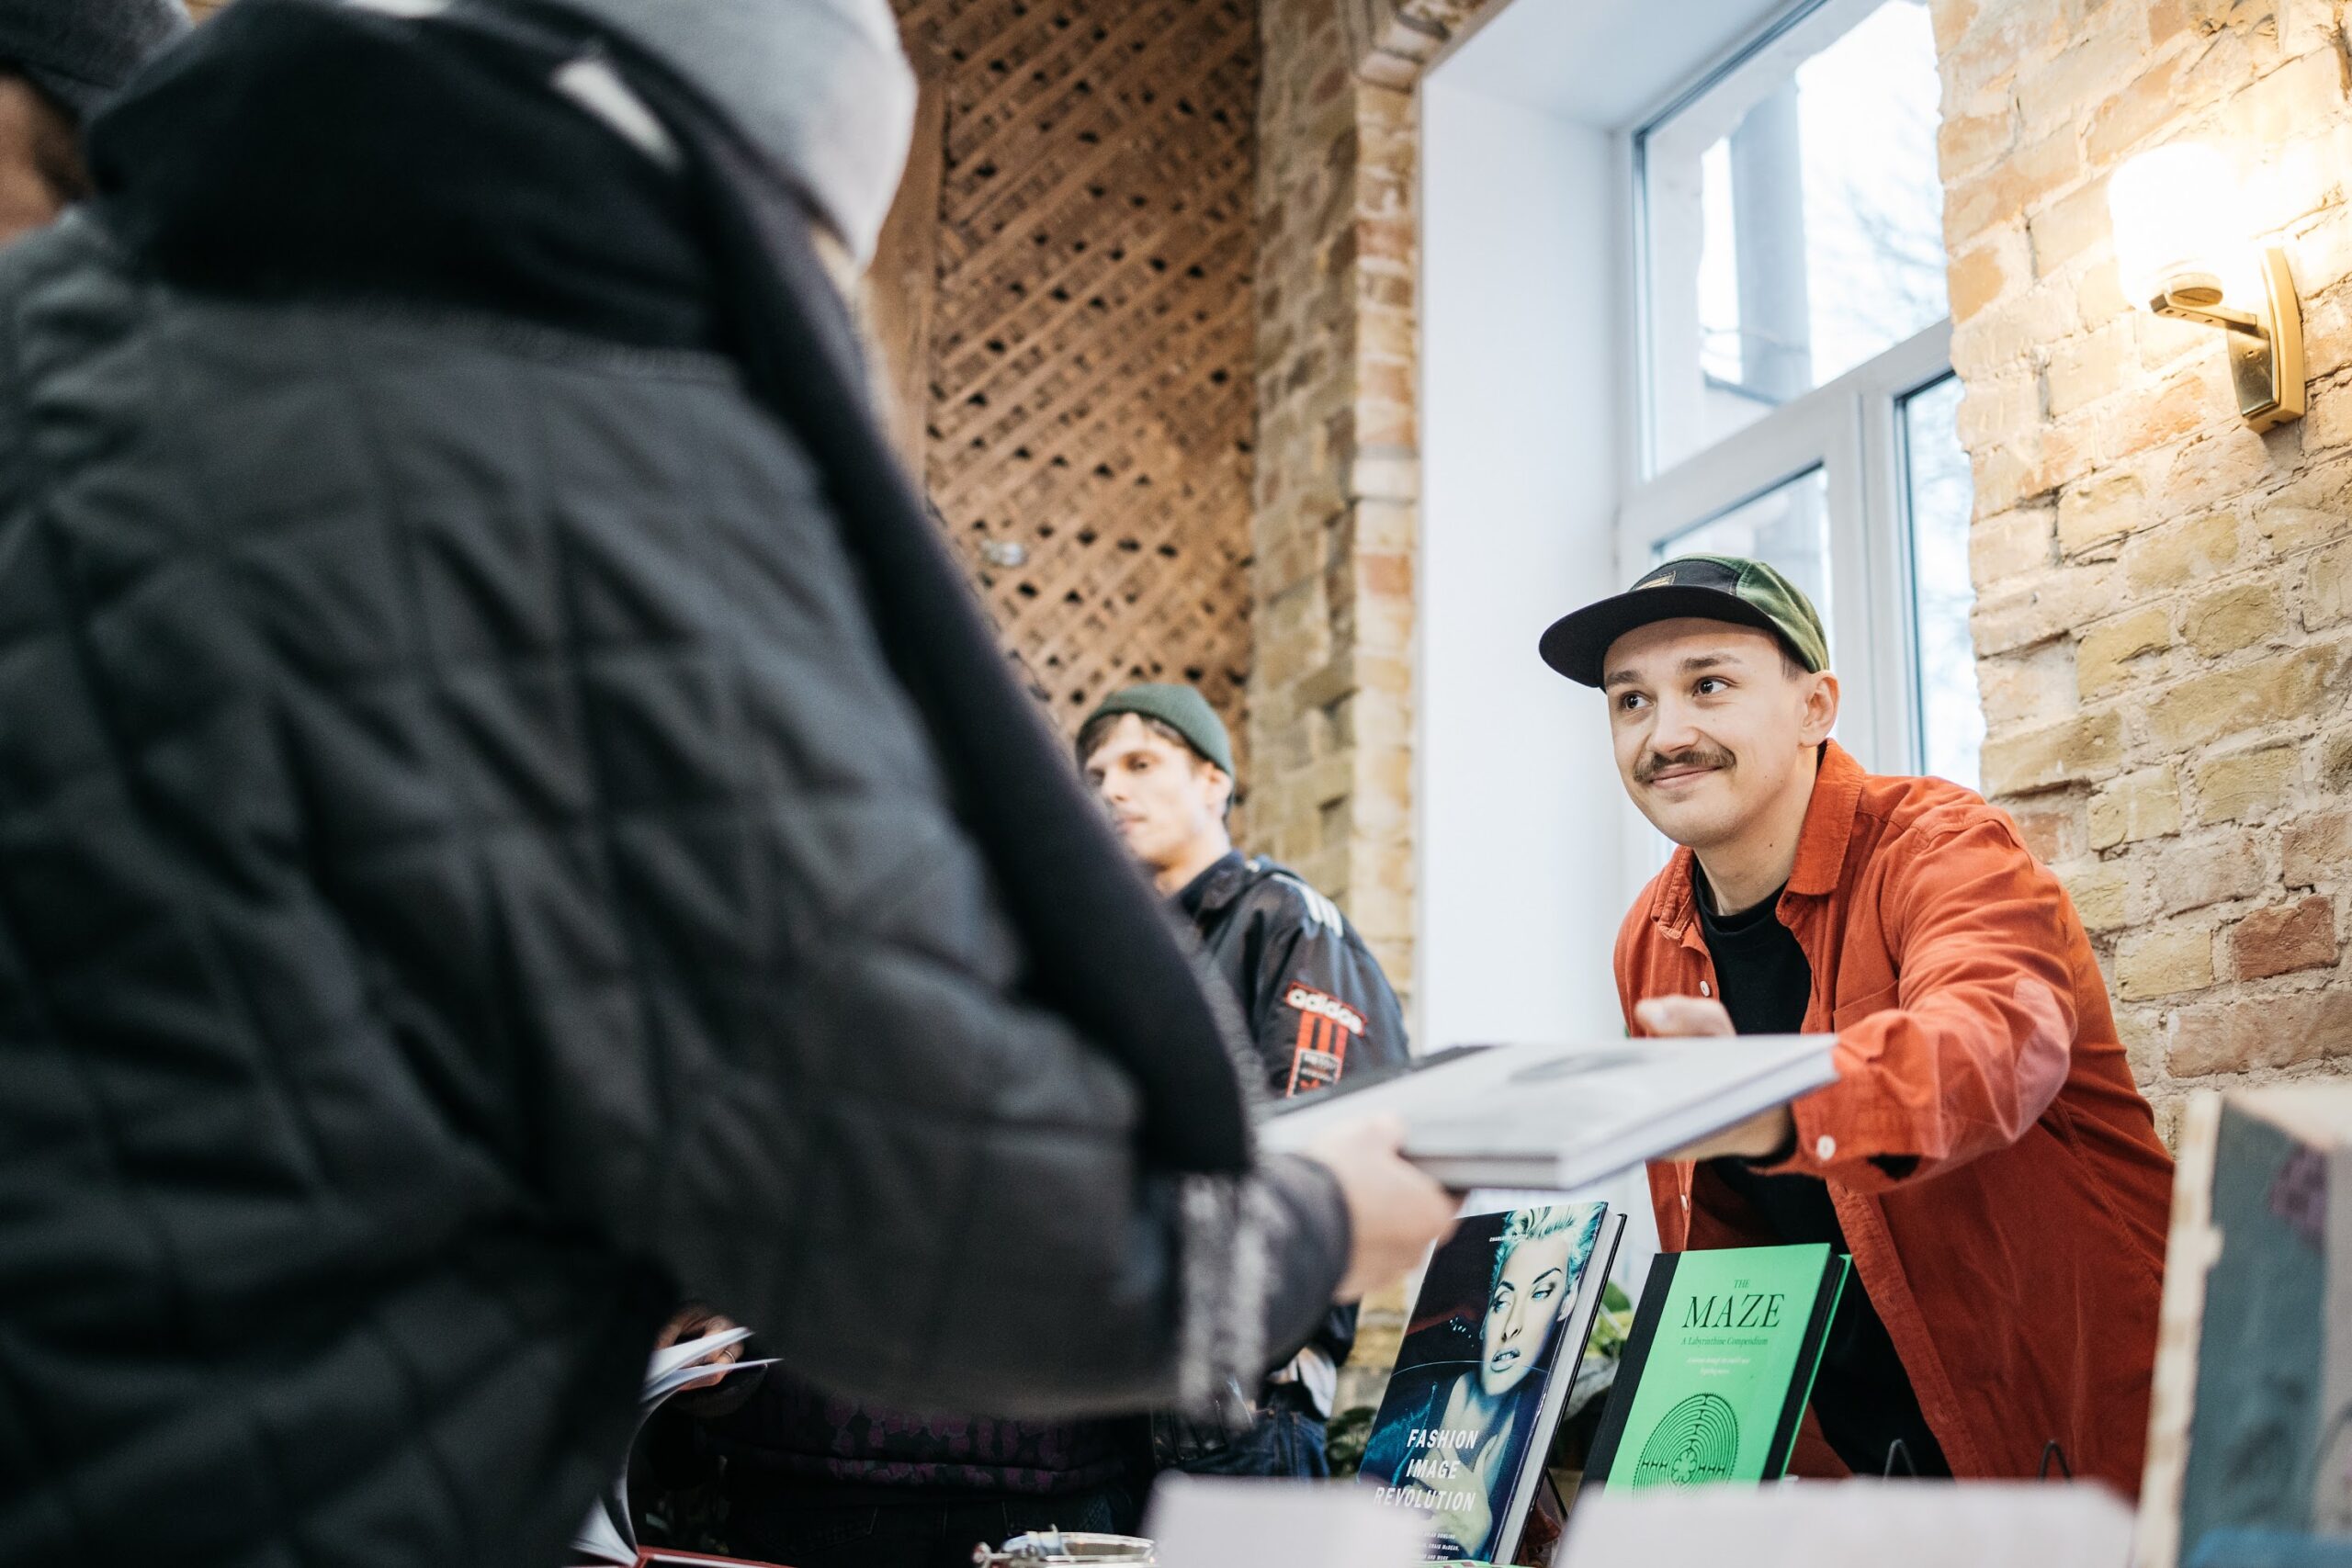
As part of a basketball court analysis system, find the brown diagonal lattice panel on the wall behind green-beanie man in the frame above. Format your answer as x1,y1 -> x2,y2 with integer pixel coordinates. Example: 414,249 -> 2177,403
899,0 -> 1259,761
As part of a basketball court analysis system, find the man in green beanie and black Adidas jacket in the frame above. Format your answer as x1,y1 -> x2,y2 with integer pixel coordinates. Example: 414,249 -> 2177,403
1077,684 -> 1407,1476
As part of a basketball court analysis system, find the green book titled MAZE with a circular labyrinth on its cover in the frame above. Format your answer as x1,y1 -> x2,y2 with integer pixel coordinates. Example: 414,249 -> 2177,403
1585,1244 -> 1849,1485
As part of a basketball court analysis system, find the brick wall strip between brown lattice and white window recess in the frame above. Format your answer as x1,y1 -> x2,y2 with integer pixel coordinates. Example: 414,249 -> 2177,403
1249,0 -> 1487,1001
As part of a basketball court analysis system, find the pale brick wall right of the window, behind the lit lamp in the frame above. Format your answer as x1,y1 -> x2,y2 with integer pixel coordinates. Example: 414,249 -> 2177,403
1936,0 -> 2352,1126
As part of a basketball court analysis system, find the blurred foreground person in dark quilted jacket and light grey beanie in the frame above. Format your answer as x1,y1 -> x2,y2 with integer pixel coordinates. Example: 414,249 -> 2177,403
0,0 -> 1452,1568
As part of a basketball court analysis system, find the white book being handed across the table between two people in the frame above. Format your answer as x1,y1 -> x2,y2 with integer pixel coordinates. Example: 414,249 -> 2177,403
1259,1034 -> 1837,1190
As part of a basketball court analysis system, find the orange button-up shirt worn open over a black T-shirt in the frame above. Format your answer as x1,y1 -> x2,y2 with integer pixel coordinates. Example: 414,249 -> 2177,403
1616,743 -> 2173,1497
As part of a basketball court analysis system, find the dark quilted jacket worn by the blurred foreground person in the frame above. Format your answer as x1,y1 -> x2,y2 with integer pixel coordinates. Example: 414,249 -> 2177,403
0,0 -> 1345,1568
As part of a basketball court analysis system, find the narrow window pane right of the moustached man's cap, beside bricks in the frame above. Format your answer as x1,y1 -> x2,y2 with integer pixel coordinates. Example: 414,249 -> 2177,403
1903,376 -> 1985,790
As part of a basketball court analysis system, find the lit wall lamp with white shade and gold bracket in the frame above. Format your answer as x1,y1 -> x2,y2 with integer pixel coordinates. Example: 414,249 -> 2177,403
2108,141 -> 2305,430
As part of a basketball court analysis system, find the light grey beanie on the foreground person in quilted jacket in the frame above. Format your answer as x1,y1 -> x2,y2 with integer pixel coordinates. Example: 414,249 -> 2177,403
550,0 -> 915,264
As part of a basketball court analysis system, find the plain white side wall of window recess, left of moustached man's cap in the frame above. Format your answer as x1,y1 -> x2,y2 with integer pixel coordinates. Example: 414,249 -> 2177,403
1416,76 -> 1628,1048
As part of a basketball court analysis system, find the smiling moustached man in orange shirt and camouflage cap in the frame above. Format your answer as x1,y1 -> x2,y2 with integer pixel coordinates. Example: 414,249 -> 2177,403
1543,555 -> 2171,1495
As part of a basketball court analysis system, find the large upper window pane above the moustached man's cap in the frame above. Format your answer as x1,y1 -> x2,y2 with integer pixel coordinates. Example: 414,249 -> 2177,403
1642,0 -> 1948,468
